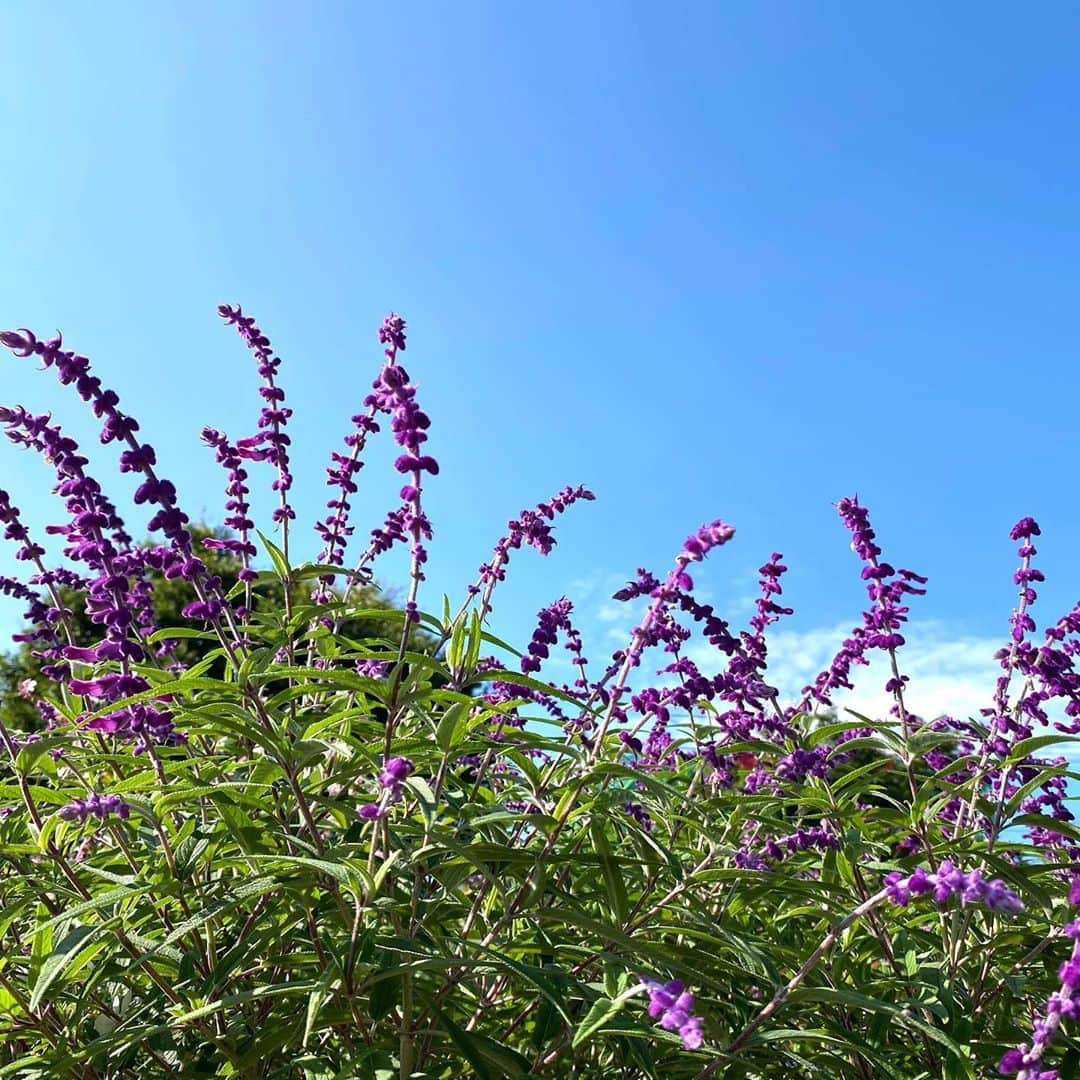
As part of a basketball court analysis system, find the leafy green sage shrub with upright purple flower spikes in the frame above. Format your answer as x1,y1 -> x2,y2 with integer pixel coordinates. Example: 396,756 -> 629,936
0,307 -> 1080,1080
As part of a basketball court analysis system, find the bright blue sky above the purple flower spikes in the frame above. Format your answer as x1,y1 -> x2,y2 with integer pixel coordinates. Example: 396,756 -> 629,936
0,0 -> 1080,721
